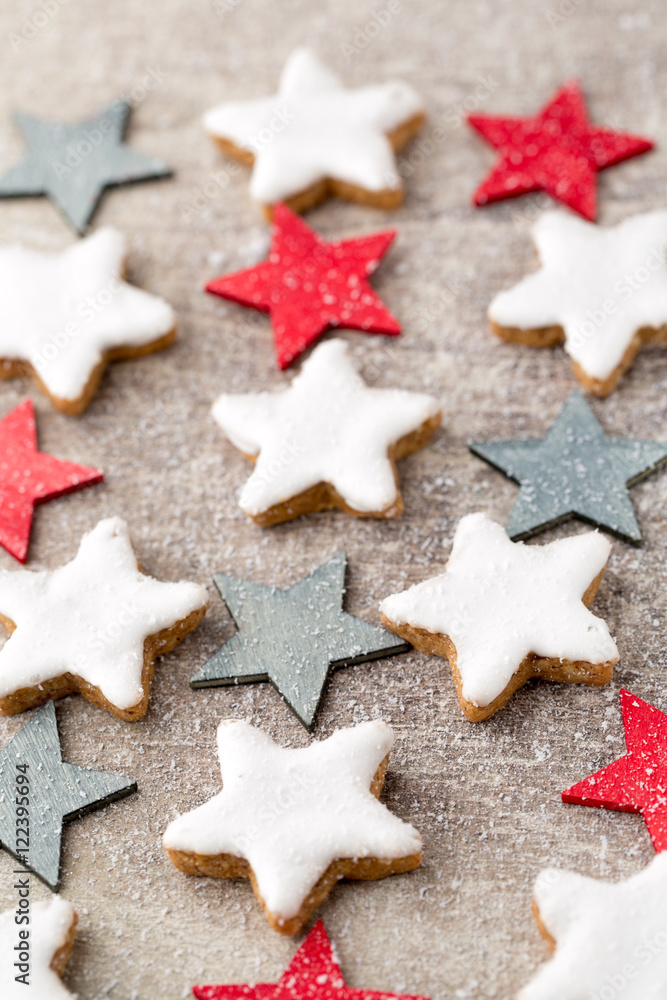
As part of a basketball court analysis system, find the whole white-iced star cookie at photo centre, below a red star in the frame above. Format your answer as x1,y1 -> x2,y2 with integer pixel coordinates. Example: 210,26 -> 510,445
213,340 -> 441,525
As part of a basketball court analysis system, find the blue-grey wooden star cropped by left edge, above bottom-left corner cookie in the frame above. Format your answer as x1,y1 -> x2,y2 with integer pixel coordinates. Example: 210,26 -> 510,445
0,701 -> 137,890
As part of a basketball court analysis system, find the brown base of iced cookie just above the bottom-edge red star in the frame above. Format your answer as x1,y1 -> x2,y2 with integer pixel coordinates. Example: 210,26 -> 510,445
166,754 -> 422,937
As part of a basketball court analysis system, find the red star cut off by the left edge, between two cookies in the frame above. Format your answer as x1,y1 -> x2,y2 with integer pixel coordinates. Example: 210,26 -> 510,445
0,399 -> 104,562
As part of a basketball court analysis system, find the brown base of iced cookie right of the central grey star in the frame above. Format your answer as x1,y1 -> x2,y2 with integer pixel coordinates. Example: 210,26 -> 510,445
382,569 -> 616,722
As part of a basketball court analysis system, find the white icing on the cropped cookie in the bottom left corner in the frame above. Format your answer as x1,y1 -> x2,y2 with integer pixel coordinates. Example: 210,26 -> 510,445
0,896 -> 75,1000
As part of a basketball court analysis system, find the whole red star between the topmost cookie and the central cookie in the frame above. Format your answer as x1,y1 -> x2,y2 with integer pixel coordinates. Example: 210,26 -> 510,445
206,205 -> 401,369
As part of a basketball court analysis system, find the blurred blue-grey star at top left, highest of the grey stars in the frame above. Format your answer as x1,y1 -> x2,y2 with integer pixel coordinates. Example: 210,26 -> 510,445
0,101 -> 171,233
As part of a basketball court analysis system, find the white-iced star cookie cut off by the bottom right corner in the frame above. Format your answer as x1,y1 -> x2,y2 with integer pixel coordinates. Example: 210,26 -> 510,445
519,852 -> 667,1000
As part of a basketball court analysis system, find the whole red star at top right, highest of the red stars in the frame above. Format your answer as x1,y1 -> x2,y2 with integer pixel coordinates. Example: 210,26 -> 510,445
468,80 -> 653,221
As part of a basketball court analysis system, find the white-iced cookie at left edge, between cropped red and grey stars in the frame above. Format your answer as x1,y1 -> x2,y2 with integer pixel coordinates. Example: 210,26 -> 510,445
0,517 -> 207,721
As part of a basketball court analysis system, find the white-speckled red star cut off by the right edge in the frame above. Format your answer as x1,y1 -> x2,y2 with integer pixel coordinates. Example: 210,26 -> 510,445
562,690 -> 667,852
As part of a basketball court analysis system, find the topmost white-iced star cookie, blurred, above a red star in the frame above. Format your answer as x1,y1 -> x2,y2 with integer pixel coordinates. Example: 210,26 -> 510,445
204,49 -> 425,215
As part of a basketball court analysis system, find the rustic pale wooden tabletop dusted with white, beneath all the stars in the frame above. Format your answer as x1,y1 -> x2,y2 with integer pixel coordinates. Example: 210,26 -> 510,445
0,0 -> 667,1000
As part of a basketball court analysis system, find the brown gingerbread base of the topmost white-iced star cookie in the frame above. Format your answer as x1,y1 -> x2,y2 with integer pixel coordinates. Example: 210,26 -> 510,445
209,113 -> 426,222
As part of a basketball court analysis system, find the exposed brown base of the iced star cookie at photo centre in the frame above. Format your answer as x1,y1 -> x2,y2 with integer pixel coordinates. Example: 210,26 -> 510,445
242,413 -> 442,528
